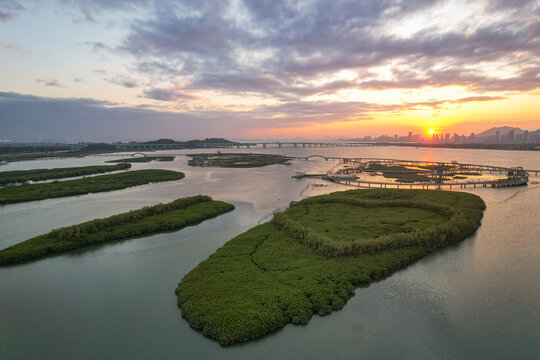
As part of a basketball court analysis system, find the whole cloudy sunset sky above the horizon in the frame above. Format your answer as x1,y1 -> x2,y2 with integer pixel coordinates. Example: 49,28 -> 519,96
0,0 -> 540,142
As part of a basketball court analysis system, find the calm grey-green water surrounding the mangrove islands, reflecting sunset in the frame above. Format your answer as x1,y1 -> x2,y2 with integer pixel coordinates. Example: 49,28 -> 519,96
0,147 -> 540,359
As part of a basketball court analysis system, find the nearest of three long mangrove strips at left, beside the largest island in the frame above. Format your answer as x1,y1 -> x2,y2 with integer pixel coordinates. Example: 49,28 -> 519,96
0,195 -> 234,265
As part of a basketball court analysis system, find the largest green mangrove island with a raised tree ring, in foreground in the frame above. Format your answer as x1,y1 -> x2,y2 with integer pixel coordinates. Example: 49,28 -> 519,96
176,189 -> 485,345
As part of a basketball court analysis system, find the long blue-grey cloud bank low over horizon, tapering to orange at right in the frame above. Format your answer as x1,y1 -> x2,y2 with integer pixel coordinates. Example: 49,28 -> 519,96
0,92 -> 504,142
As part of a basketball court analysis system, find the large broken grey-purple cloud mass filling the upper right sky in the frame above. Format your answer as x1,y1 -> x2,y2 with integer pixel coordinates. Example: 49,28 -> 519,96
115,0 -> 540,100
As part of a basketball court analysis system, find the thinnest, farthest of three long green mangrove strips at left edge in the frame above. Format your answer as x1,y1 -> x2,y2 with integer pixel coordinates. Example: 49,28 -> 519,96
0,164 -> 131,185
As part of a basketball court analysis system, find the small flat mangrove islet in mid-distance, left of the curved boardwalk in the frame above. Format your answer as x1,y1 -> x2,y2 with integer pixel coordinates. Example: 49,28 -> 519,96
187,152 -> 290,168
